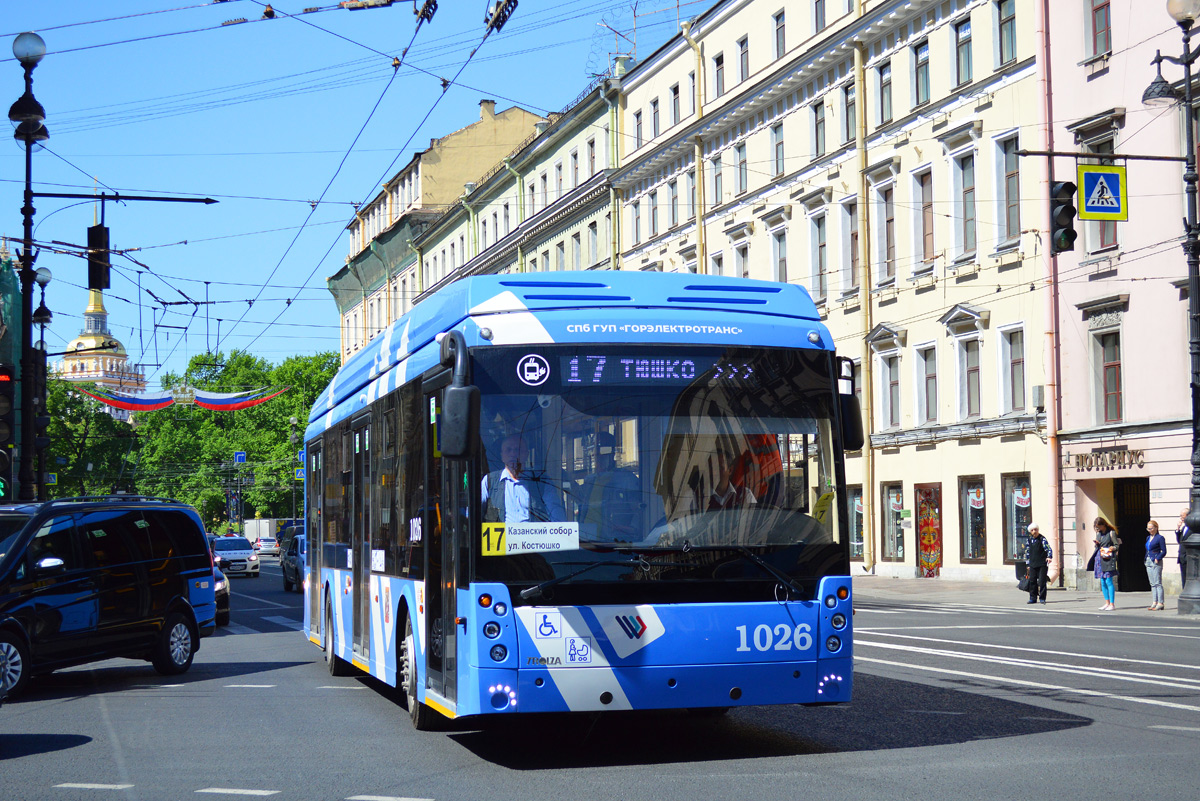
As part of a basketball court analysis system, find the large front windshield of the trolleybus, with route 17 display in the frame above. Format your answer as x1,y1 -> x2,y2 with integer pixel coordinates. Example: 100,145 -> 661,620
473,344 -> 848,600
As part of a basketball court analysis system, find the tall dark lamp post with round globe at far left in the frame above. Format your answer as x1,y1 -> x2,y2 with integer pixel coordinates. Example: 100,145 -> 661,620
8,31 -> 49,501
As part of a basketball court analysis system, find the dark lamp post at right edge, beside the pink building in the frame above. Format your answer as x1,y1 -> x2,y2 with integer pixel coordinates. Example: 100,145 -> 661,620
1141,0 -> 1200,615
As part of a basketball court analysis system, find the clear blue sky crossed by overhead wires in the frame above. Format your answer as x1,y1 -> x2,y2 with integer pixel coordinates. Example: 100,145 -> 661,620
0,0 -> 696,389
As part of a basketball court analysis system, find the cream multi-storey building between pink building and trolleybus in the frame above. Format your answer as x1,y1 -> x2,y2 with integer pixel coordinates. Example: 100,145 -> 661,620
613,0 -> 1055,580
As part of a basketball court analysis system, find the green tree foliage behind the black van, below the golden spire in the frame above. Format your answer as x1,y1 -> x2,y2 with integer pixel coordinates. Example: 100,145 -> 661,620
47,350 -> 338,529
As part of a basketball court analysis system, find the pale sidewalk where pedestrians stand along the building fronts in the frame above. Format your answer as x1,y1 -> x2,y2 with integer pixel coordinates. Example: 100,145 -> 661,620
852,574 -> 1200,624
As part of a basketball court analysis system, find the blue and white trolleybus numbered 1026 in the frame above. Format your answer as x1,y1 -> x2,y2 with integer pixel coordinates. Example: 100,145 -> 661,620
304,272 -> 863,729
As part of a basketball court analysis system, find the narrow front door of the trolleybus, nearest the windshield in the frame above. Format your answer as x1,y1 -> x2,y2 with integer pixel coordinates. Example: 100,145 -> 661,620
424,391 -> 467,701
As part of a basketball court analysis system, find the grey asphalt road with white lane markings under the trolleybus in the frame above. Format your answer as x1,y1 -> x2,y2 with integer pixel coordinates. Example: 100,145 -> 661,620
0,568 -> 1200,801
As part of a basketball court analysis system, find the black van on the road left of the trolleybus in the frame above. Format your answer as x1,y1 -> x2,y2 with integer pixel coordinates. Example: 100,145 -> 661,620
0,495 -> 216,697
